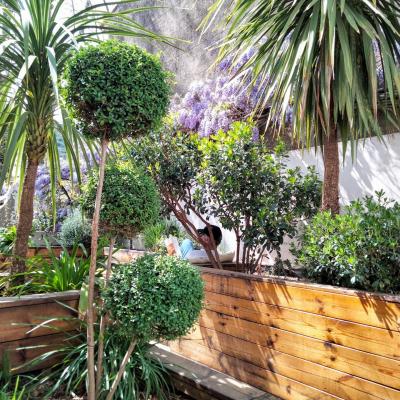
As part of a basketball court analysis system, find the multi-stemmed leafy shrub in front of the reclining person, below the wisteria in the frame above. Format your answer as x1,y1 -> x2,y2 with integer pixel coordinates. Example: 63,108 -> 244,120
132,122 -> 320,272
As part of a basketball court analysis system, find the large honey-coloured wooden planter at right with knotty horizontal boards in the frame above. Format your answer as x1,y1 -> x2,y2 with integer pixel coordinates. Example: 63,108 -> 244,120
170,268 -> 400,400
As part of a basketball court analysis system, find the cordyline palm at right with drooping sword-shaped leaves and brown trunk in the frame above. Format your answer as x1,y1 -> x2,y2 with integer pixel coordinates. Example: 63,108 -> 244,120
203,0 -> 400,213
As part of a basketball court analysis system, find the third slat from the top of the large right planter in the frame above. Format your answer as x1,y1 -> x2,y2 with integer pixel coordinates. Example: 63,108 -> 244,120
199,310 -> 400,389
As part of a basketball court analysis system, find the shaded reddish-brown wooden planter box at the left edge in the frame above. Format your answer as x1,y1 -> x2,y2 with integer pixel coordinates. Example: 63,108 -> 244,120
0,290 -> 79,372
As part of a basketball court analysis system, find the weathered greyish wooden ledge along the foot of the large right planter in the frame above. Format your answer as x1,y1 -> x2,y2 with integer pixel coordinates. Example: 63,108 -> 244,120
150,344 -> 279,400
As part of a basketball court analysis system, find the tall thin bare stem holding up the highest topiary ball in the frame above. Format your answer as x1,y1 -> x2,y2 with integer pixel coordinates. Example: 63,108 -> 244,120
87,138 -> 108,400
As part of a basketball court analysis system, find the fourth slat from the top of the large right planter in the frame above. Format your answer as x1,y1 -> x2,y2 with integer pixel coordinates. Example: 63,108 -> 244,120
182,327 -> 400,400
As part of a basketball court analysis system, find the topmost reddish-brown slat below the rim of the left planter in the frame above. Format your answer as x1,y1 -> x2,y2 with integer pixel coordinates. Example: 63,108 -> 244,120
0,300 -> 78,343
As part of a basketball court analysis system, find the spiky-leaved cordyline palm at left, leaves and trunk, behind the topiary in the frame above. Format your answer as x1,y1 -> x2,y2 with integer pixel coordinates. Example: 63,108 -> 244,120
0,0 -> 172,284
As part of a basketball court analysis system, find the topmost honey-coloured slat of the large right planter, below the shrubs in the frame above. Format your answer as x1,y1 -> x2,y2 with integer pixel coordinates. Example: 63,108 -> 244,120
202,269 -> 400,332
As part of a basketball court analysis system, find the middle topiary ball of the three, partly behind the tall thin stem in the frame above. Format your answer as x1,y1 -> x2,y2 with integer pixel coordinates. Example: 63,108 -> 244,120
81,162 -> 160,237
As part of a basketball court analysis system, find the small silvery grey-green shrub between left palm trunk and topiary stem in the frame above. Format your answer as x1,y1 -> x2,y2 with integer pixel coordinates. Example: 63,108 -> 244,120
59,209 -> 91,248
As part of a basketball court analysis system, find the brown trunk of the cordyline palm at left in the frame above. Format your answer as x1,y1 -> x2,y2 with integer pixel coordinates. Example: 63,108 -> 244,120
11,160 -> 38,285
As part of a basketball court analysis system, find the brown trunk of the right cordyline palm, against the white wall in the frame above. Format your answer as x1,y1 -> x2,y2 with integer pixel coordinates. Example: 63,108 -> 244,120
321,128 -> 340,214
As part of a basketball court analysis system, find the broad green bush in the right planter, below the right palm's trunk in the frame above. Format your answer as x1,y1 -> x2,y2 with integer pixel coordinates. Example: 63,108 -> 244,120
296,192 -> 400,293
